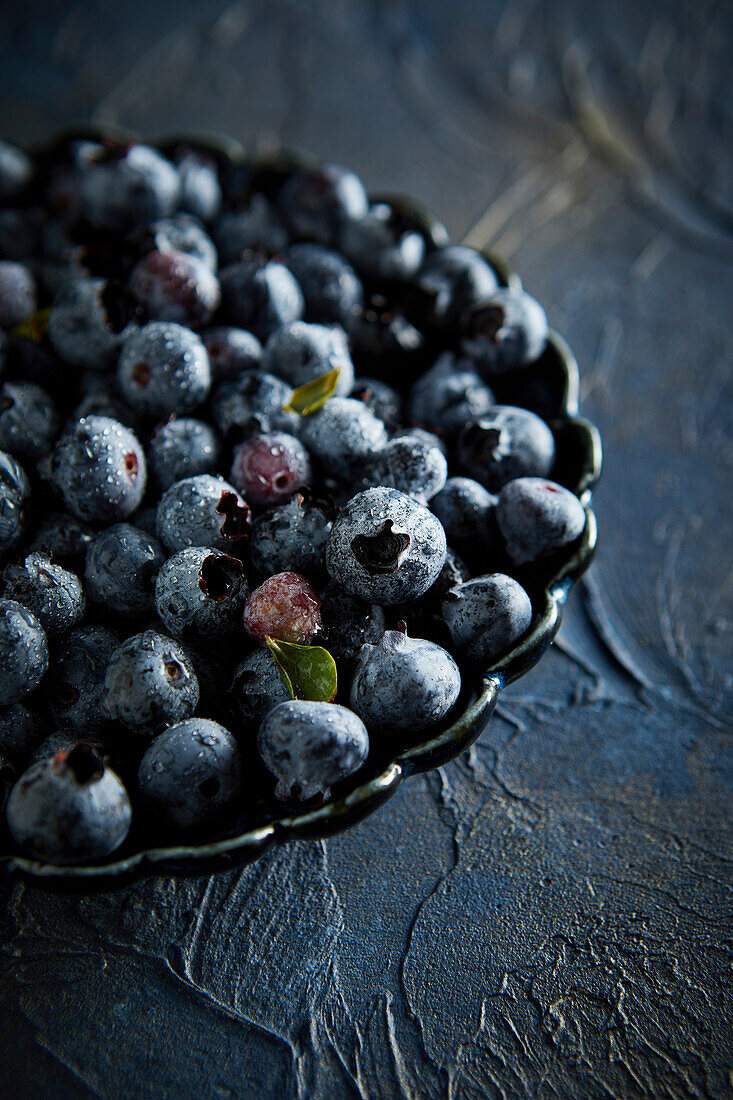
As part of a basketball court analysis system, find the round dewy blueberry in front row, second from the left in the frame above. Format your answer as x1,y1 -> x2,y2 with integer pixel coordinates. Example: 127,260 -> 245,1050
138,718 -> 242,829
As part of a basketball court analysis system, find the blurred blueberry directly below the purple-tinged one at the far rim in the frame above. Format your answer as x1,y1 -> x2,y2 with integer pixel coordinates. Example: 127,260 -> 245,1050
286,242 -> 364,328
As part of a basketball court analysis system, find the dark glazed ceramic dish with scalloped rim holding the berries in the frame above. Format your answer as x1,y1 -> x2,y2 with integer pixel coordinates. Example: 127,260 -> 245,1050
0,130 -> 601,891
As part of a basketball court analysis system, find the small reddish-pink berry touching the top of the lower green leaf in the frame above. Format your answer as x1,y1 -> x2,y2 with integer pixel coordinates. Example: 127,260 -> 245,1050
244,573 -> 321,645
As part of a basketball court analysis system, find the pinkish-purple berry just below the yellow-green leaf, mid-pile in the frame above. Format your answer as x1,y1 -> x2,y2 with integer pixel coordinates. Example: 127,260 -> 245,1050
229,432 -> 313,504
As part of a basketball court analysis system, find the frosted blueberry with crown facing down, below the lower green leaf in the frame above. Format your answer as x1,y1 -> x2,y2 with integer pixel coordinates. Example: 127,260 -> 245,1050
258,700 -> 369,802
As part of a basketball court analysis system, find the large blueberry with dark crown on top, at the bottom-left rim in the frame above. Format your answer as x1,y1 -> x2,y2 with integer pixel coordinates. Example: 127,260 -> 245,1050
7,745 -> 132,864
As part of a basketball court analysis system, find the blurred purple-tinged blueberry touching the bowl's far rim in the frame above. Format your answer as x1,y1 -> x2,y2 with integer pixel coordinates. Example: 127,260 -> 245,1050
277,164 -> 369,244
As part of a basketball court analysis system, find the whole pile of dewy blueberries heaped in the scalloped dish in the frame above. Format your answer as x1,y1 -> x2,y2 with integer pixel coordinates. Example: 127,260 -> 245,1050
0,136 -> 586,864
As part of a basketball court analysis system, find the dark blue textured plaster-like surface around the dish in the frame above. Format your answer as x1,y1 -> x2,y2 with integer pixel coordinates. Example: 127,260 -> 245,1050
0,0 -> 733,1100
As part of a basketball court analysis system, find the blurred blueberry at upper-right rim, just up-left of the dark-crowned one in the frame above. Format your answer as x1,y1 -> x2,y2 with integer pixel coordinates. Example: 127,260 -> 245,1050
417,244 -> 499,328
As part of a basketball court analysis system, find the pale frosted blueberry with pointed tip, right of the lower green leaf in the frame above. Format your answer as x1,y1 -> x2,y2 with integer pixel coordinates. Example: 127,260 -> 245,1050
349,630 -> 461,733
